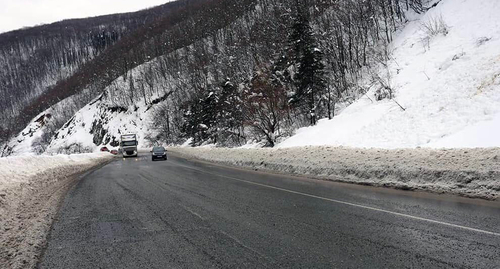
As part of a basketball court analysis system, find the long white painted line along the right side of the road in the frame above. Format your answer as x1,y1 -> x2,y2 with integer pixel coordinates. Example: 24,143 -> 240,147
175,163 -> 500,237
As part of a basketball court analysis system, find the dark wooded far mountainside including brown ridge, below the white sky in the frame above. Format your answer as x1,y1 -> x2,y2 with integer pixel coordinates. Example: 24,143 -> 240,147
0,0 -> 248,144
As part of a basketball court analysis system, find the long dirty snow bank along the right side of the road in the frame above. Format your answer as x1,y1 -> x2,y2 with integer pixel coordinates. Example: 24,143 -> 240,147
171,147 -> 500,199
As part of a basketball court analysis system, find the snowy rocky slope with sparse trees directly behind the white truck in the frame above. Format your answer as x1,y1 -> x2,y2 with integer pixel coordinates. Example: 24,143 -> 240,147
0,49 -> 173,157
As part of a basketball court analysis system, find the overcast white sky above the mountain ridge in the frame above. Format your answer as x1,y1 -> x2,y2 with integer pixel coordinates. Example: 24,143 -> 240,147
0,0 -> 172,33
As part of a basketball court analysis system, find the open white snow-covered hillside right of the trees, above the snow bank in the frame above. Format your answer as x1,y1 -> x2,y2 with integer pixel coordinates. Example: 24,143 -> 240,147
278,0 -> 500,148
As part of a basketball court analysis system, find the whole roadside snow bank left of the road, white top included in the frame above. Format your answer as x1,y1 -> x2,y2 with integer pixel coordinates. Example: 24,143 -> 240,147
0,153 -> 113,268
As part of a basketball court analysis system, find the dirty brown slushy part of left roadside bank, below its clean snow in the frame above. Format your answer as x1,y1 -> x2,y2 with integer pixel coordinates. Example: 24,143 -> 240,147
0,154 -> 113,268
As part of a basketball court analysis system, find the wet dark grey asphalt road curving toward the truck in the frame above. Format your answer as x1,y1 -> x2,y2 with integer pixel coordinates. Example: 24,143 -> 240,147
39,154 -> 500,268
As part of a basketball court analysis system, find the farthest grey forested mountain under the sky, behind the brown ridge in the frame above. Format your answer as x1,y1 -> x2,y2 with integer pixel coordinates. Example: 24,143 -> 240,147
0,4 -> 180,136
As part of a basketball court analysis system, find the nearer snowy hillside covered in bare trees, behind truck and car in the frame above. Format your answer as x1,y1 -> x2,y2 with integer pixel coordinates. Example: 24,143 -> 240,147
2,0 -> 446,156
